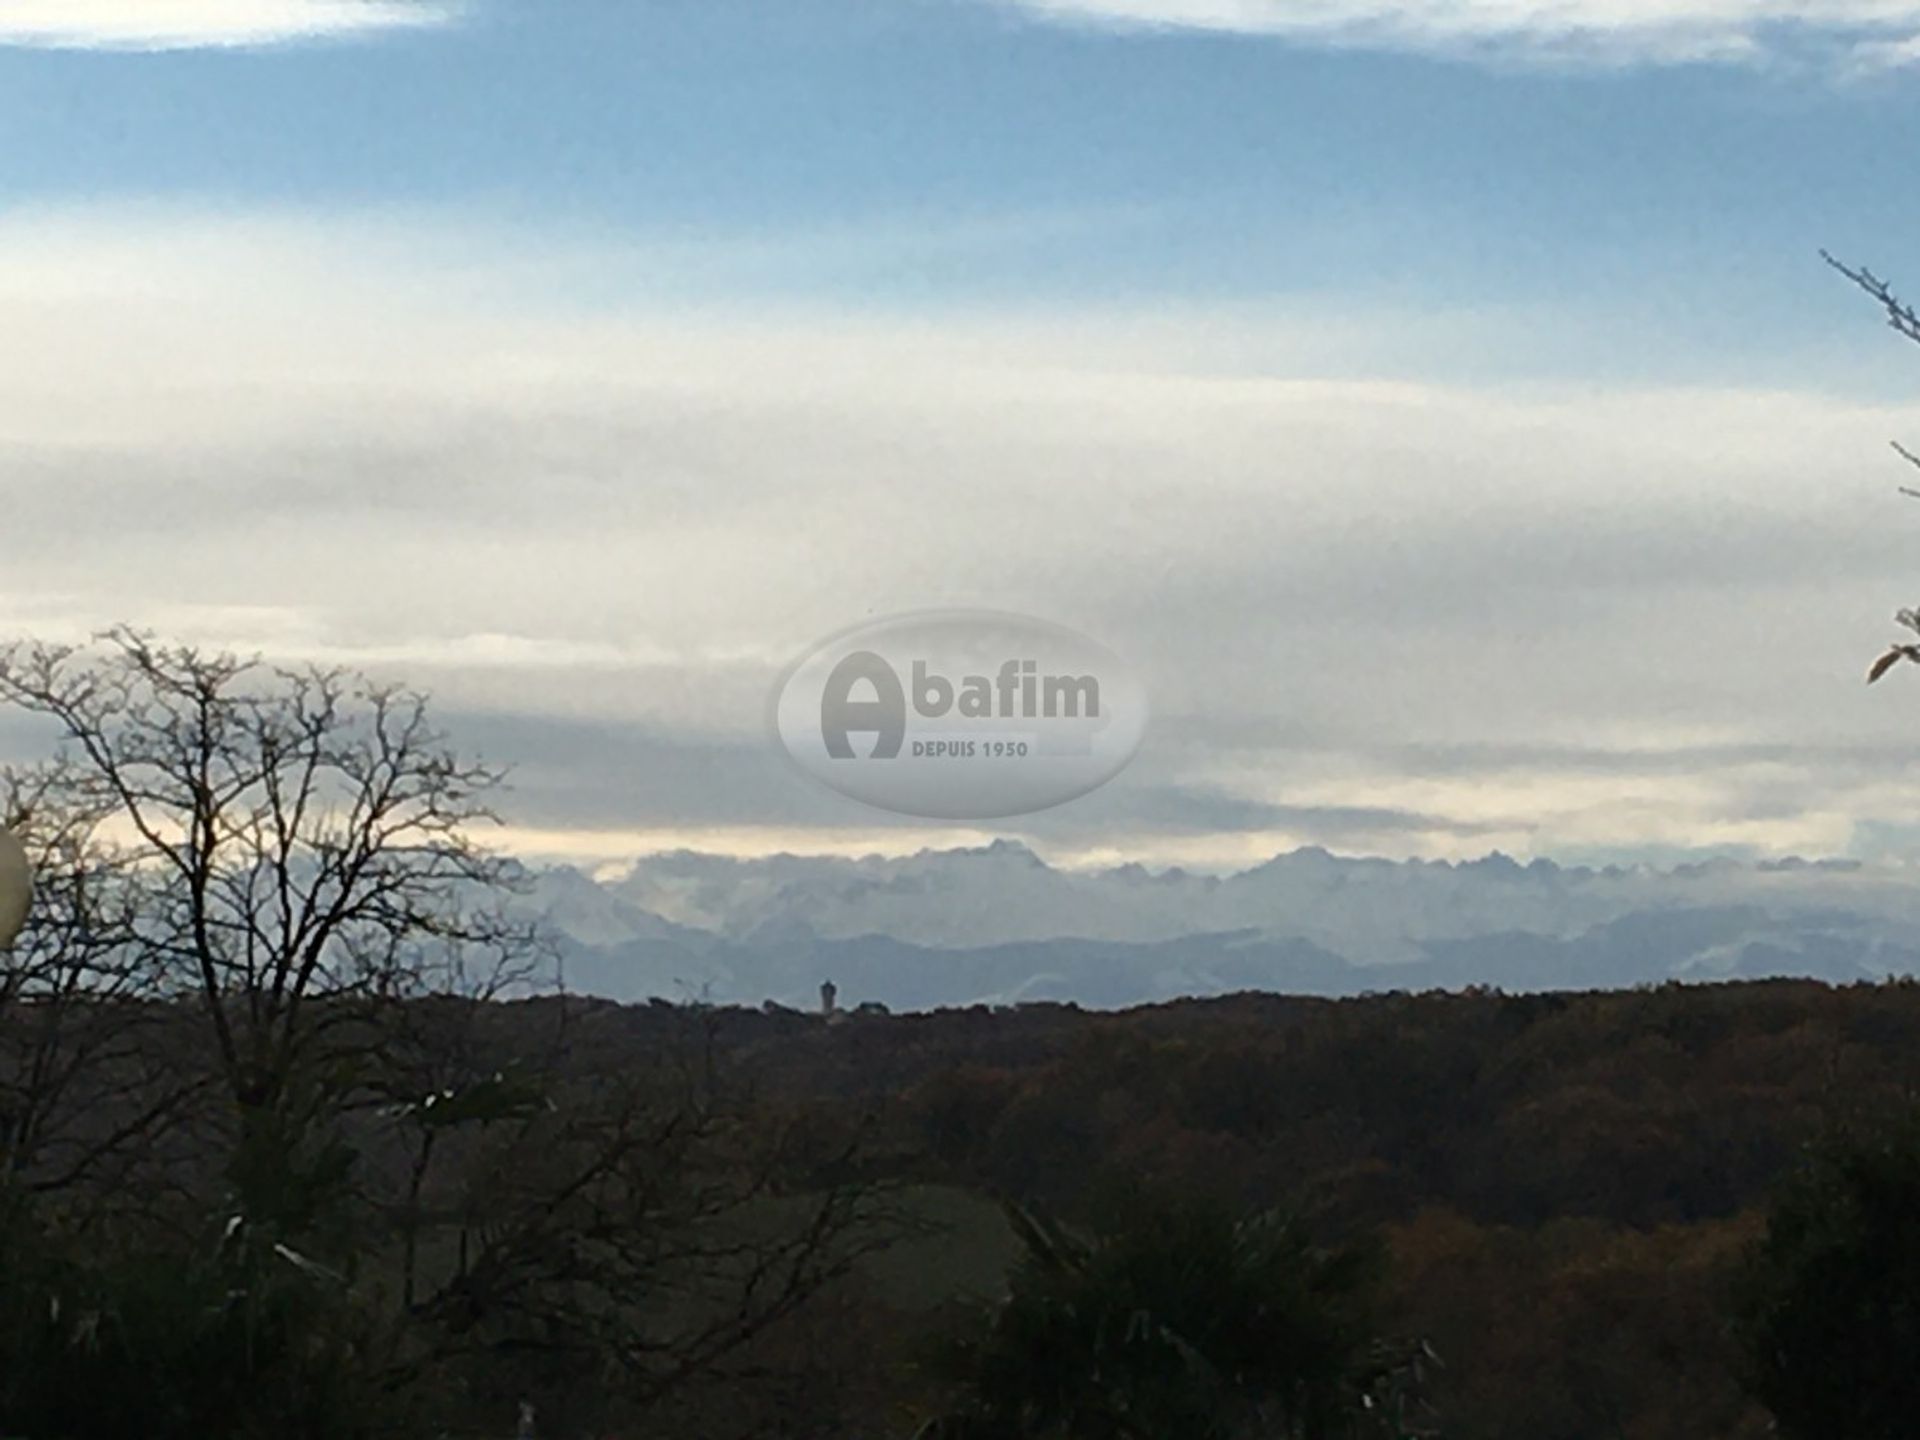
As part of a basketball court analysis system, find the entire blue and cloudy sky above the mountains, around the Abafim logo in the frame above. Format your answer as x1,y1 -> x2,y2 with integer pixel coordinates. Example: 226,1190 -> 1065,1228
0,0 -> 1920,868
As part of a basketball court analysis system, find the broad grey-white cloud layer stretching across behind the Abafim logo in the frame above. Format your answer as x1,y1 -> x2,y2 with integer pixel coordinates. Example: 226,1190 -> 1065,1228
0,211 -> 1920,858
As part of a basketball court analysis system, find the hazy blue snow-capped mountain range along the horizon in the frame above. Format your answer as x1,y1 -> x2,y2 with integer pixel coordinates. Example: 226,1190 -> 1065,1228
503,841 -> 1920,1010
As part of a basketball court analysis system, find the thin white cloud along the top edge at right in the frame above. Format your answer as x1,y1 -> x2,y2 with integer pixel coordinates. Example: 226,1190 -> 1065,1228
1002,0 -> 1920,63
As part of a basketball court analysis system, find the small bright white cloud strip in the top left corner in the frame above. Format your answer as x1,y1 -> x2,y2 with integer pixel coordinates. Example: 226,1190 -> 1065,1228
0,0 -> 457,50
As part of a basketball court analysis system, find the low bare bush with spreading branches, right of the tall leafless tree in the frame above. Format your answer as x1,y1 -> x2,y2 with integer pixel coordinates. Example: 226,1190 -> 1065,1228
382,1012 -> 914,1436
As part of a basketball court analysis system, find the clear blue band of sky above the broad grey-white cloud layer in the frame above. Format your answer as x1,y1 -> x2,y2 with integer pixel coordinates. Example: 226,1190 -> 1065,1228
11,0 -> 1920,371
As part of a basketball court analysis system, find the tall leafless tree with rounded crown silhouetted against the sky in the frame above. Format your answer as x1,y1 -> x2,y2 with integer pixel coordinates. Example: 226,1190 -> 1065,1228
0,628 -> 530,1136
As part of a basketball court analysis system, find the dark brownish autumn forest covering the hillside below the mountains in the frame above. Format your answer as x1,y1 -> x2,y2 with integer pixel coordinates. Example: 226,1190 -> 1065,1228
15,981 -> 1920,1440
